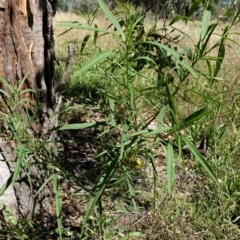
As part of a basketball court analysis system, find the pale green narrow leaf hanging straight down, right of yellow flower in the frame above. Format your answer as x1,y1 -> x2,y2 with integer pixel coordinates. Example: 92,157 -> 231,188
167,143 -> 174,192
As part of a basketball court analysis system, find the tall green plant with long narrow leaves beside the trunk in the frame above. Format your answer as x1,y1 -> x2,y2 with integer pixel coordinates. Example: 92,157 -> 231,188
54,0 -> 240,237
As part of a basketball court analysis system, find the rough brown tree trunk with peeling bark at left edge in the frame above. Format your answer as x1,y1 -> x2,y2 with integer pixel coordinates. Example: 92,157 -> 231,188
0,0 -> 61,221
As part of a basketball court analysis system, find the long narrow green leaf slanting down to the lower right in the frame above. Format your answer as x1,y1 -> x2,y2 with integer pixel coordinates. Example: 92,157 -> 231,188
182,136 -> 218,184
